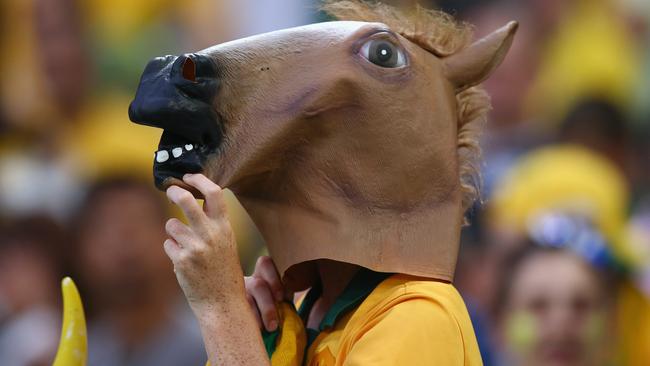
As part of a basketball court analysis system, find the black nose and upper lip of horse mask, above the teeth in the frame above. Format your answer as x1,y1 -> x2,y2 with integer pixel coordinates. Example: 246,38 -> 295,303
129,54 -> 221,145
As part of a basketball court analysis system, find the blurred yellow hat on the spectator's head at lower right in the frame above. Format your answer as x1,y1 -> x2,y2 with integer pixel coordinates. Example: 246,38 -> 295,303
487,144 -> 633,263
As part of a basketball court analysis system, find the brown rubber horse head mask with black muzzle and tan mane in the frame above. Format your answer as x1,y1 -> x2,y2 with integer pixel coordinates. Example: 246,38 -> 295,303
129,1 -> 517,281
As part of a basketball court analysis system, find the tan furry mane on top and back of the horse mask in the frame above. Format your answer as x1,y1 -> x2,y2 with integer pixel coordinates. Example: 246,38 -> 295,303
321,0 -> 490,210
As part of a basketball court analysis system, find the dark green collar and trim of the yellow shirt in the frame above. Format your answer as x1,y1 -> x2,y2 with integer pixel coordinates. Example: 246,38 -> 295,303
262,268 -> 392,357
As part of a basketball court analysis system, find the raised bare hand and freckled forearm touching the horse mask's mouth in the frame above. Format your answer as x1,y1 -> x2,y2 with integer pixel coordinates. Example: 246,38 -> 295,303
163,174 -> 270,366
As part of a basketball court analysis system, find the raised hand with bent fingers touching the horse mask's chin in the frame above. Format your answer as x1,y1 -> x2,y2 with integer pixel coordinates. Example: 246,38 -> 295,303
164,174 -> 245,313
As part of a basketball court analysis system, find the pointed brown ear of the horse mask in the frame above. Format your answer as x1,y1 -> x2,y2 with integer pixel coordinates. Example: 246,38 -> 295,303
443,22 -> 519,92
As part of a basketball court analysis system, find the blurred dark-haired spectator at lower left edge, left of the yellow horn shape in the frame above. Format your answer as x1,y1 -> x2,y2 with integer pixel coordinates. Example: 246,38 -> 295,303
0,217 -> 65,366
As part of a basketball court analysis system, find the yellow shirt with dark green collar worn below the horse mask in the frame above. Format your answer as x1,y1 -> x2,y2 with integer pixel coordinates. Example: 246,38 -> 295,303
264,269 -> 482,366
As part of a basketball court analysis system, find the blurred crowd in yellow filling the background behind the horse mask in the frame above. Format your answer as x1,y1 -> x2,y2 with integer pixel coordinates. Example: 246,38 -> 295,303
0,0 -> 650,366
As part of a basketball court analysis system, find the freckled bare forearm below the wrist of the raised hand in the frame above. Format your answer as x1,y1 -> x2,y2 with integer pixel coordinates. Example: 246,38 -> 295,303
195,294 -> 271,366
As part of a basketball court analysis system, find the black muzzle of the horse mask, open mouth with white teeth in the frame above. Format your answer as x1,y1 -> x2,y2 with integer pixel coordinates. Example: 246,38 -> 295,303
129,54 -> 223,189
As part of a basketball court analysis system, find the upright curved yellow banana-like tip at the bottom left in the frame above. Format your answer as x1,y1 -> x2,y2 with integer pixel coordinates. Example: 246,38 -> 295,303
52,277 -> 88,366
